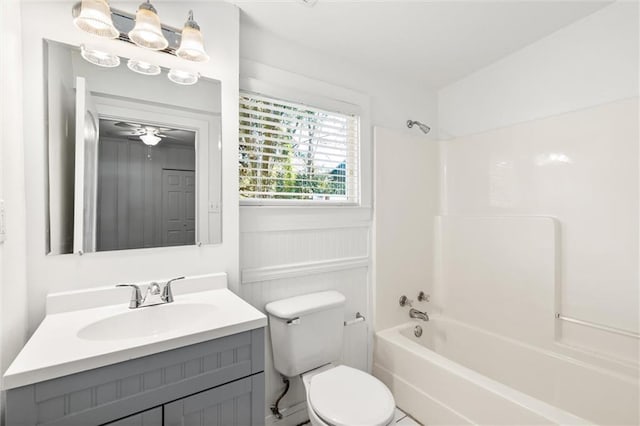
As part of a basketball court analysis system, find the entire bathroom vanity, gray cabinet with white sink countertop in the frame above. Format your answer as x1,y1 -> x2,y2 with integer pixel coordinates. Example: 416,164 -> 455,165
5,279 -> 266,426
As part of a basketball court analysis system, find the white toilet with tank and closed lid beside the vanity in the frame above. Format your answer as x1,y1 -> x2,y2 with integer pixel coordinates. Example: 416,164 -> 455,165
265,291 -> 395,426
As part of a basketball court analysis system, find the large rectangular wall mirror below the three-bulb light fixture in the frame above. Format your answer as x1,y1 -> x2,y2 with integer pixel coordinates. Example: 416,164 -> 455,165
44,40 -> 221,254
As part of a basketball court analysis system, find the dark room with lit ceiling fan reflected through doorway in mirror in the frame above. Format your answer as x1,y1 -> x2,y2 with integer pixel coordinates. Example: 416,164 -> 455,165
95,119 -> 196,251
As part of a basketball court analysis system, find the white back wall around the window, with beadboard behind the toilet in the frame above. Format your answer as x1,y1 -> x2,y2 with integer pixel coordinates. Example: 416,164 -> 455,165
240,18 -> 437,425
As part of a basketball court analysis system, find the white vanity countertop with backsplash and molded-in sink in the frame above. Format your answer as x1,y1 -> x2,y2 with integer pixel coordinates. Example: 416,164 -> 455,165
3,274 -> 267,389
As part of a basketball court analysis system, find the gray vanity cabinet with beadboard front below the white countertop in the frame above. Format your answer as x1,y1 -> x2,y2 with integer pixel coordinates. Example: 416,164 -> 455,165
5,328 -> 265,426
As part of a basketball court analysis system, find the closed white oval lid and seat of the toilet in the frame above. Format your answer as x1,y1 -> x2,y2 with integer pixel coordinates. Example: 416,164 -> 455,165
308,365 -> 395,426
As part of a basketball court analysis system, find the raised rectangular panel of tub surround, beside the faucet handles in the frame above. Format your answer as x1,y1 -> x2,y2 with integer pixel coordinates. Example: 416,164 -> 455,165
432,216 -> 558,347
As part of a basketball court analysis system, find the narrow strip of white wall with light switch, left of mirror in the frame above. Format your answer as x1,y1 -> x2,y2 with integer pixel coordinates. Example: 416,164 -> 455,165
0,0 -> 27,392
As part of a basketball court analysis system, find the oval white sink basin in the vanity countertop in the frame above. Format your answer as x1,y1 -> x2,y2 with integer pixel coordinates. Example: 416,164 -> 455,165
77,303 -> 216,340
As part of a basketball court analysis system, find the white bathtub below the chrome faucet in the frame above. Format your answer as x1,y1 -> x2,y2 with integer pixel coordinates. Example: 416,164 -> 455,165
373,317 -> 639,425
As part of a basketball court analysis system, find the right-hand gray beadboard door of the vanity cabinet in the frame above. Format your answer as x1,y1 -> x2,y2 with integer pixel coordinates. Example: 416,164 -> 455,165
164,373 -> 264,426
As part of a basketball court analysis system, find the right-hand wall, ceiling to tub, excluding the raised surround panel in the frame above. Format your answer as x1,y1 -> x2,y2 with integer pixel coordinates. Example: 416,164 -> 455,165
439,2 -> 640,362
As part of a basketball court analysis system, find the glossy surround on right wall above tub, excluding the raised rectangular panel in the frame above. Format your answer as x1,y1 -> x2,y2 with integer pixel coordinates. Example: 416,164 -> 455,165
444,98 -> 640,363
